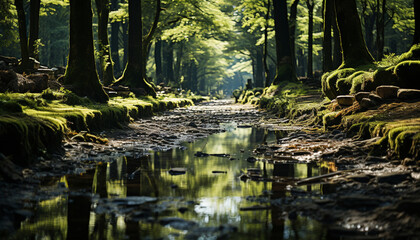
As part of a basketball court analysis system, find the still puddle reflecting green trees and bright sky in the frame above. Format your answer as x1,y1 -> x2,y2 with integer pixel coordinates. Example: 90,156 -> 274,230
12,125 -> 331,239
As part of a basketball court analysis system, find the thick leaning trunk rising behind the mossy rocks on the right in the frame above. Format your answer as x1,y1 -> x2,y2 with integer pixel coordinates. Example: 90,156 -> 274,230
334,0 -> 374,68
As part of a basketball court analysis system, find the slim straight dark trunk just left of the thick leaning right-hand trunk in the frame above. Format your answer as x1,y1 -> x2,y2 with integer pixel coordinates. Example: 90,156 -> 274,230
322,0 -> 334,72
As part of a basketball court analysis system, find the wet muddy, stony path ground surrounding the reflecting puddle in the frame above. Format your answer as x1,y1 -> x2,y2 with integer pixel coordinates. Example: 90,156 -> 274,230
0,100 -> 420,239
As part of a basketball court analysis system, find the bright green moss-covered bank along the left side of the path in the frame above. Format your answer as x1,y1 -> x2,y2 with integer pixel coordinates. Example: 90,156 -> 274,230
0,89 -> 207,166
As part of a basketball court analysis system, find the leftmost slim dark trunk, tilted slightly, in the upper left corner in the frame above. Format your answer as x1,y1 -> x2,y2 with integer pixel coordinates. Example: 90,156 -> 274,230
15,0 -> 29,65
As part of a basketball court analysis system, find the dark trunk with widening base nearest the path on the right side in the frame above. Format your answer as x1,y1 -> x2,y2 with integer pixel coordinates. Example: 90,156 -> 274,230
273,0 -> 297,85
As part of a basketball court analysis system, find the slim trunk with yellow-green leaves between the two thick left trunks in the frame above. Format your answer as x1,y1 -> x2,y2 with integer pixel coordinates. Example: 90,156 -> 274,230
95,0 -> 115,85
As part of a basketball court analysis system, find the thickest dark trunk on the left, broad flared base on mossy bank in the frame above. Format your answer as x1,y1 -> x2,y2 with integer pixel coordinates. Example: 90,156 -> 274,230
63,0 -> 108,102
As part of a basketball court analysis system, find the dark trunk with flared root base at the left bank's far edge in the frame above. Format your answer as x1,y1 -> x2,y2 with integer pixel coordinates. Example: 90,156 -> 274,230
116,0 -> 156,97
